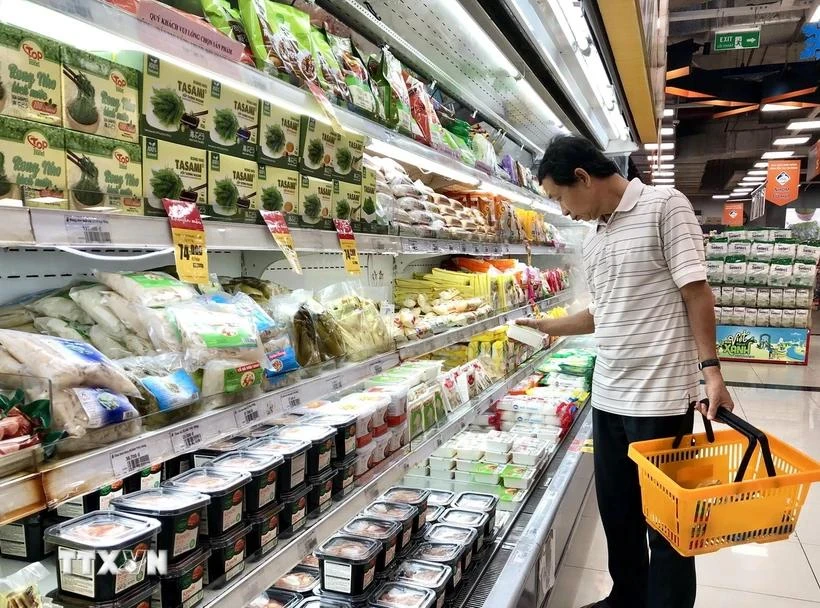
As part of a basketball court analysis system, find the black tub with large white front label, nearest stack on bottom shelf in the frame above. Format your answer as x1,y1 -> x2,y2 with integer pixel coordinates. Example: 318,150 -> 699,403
316,534 -> 382,595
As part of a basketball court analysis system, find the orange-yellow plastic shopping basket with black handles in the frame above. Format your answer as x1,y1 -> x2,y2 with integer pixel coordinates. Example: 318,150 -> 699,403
629,408 -> 820,556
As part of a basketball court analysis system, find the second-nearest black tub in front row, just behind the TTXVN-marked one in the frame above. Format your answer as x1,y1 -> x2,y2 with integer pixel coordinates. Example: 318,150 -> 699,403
111,488 -> 211,562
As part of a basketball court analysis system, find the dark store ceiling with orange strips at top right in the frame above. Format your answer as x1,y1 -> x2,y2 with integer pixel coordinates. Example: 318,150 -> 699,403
633,0 -> 820,204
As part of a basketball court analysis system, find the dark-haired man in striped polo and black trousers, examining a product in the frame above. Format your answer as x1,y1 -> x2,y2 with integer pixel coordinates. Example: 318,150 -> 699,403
518,136 -> 734,608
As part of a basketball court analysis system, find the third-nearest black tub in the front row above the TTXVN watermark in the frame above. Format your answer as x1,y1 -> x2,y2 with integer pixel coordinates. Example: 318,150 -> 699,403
162,467 -> 251,536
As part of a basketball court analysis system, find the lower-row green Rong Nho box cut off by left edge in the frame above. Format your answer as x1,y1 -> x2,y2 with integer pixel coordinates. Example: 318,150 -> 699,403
0,116 -> 68,209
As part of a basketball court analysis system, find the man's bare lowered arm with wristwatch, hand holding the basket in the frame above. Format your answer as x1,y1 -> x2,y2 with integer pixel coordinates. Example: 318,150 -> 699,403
680,281 -> 734,420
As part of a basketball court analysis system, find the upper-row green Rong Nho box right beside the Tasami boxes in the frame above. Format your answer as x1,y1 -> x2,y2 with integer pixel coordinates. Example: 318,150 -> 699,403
61,46 -> 142,144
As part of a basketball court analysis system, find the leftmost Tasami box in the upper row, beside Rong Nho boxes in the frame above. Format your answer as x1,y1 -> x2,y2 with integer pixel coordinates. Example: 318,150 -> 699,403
140,54 -> 207,148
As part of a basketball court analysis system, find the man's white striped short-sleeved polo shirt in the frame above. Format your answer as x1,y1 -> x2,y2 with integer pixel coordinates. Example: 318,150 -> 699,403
583,179 -> 711,416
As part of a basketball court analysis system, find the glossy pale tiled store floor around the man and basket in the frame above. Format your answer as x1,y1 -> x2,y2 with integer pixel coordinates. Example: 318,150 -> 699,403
548,388 -> 820,608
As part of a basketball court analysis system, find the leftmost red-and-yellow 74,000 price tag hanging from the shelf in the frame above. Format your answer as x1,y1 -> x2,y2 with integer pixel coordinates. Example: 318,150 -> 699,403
162,198 -> 210,285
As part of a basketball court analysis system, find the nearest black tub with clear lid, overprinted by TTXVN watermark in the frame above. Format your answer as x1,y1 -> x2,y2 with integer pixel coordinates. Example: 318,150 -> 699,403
45,511 -> 160,602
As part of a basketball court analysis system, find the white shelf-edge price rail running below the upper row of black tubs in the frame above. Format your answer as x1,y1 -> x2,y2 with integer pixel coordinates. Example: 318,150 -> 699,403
203,341 -> 561,608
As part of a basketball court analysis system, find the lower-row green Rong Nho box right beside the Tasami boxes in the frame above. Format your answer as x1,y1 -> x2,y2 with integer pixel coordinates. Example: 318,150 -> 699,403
65,131 -> 143,215
